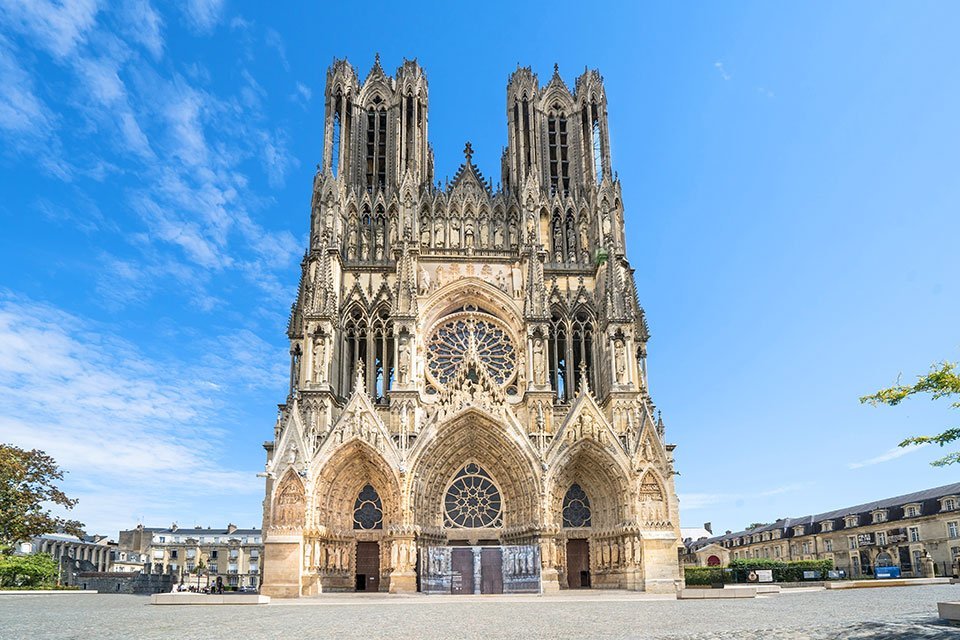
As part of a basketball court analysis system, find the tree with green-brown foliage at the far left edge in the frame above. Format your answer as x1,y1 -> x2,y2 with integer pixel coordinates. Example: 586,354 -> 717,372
0,444 -> 83,553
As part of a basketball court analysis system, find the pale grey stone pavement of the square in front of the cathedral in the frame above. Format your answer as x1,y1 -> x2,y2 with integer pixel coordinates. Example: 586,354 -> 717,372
0,585 -> 960,640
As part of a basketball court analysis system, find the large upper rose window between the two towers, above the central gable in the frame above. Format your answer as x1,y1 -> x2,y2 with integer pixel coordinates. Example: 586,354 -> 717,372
427,312 -> 517,386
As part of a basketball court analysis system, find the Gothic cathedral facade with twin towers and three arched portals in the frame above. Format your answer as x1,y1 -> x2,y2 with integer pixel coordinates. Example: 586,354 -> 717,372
262,57 -> 682,597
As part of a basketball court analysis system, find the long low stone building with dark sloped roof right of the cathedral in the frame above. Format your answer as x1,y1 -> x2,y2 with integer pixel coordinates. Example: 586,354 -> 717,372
686,483 -> 960,577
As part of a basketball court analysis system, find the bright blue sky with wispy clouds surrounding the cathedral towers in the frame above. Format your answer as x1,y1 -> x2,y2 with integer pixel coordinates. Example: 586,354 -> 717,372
0,0 -> 960,535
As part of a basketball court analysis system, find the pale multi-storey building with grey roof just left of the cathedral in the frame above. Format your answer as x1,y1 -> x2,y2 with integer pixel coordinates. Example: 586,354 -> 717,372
118,524 -> 263,587
